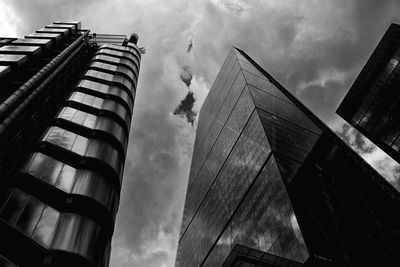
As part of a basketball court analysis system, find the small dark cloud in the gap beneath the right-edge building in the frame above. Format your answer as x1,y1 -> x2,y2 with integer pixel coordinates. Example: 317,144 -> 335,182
336,123 -> 375,155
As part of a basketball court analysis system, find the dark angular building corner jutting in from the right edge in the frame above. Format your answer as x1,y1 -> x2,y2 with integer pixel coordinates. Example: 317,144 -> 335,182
336,24 -> 400,163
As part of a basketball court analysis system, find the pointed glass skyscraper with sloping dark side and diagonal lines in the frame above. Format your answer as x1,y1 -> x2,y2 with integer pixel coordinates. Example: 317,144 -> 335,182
175,49 -> 400,267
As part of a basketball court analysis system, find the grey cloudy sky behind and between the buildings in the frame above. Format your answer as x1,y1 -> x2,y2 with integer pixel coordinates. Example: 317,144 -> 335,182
0,0 -> 400,267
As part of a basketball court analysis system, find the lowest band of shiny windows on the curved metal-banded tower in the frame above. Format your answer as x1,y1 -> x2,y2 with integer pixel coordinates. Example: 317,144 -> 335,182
0,189 -> 107,263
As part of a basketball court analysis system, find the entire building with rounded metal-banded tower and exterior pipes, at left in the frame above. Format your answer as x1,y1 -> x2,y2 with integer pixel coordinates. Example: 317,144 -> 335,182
0,21 -> 141,266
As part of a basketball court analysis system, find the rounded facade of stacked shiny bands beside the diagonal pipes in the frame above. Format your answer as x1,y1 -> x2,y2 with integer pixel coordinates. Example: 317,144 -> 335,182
0,22 -> 141,266
